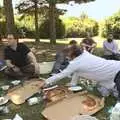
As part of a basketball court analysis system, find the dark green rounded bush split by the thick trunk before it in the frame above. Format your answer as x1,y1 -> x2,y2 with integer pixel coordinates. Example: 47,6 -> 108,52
39,19 -> 65,38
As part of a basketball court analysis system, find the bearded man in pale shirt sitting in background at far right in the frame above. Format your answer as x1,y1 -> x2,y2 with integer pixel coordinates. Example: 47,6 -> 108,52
103,34 -> 120,60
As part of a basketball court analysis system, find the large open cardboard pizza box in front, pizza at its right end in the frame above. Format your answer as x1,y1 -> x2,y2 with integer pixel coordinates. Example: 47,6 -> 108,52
42,91 -> 104,120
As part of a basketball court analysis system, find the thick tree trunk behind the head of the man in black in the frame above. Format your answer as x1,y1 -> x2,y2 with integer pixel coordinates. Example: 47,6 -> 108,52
3,0 -> 16,34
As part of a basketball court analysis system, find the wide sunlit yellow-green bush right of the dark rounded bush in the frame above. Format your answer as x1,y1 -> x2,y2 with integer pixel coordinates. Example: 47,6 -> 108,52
64,17 -> 98,37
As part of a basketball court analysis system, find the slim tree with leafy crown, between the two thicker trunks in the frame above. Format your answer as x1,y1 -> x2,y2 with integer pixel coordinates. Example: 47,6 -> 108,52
16,0 -> 47,42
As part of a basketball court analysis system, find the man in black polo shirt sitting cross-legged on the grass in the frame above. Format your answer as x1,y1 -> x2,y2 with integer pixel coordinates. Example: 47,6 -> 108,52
4,34 -> 39,79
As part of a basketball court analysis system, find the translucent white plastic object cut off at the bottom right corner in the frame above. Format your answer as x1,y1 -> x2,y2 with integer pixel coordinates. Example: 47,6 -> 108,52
110,103 -> 120,120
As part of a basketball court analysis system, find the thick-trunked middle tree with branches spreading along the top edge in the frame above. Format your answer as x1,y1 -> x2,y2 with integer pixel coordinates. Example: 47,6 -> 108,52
19,0 -> 94,44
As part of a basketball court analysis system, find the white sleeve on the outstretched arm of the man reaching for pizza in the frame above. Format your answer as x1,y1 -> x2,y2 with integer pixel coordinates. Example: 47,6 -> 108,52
45,63 -> 78,84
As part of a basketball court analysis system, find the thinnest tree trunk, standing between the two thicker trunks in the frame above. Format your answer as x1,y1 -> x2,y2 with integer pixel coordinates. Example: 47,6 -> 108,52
35,0 -> 39,43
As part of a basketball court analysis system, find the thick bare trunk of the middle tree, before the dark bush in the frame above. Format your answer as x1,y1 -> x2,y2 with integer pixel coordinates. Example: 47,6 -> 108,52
49,2 -> 56,44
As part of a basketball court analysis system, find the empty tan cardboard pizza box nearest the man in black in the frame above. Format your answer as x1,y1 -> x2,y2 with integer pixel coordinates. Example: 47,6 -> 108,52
7,79 -> 43,104
